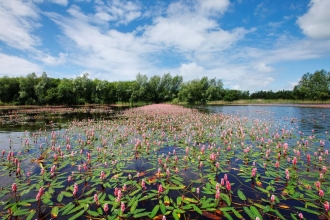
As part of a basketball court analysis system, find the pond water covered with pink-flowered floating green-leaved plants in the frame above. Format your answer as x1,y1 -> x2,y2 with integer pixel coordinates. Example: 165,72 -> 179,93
0,106 -> 330,219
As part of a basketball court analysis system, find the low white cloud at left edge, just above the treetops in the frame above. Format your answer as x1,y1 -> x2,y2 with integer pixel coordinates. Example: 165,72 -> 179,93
0,53 -> 42,77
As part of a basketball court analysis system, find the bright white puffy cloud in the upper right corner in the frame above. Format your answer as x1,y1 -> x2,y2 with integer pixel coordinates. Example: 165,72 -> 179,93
297,0 -> 330,39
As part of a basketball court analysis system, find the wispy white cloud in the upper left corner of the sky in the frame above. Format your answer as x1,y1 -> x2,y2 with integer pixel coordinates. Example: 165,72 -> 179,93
0,0 -> 40,50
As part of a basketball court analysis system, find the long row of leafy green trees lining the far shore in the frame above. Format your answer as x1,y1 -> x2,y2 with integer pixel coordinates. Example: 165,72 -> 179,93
0,70 -> 330,105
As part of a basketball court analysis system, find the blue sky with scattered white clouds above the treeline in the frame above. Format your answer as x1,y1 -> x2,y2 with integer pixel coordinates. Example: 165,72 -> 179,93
0,0 -> 330,92
